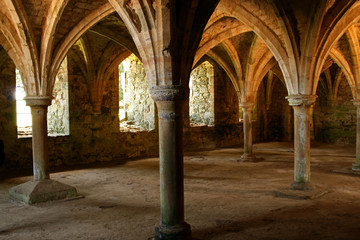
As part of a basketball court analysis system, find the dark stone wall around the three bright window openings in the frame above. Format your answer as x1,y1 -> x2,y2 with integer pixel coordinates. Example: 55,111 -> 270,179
0,53 -> 243,170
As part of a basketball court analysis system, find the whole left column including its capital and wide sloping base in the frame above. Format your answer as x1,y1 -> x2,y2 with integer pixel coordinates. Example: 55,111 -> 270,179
9,97 -> 76,204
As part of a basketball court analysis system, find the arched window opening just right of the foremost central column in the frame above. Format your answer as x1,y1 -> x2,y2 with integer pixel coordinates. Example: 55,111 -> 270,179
189,61 -> 214,126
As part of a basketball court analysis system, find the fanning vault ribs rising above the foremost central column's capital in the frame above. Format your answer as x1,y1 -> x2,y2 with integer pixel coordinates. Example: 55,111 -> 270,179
109,0 -> 218,90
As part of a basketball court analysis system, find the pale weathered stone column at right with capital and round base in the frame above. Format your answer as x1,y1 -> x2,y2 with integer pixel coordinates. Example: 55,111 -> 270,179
287,95 -> 316,190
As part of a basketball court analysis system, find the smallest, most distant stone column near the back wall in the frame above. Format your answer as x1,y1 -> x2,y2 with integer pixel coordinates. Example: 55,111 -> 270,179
240,103 -> 257,162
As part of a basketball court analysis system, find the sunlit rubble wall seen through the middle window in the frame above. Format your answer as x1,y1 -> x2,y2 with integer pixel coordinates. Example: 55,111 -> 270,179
122,54 -> 155,130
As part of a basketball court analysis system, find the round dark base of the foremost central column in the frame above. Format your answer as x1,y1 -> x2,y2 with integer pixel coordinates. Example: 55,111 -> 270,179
154,223 -> 191,240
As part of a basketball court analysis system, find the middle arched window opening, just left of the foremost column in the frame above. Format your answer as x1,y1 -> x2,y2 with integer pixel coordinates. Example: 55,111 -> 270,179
119,54 -> 155,131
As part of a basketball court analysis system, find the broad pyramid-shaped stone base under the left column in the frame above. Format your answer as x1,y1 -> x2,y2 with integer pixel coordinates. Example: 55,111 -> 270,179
9,179 -> 77,204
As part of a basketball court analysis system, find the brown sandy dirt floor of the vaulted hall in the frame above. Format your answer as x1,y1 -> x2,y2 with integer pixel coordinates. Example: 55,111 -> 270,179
0,143 -> 360,240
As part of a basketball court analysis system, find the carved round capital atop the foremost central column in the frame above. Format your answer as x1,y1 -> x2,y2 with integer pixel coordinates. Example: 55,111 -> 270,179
150,85 -> 189,102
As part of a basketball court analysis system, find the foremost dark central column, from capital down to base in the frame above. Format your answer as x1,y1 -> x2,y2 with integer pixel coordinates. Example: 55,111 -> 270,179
151,86 -> 191,240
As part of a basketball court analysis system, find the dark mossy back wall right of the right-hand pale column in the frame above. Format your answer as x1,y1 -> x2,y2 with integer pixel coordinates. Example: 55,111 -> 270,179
314,75 -> 356,143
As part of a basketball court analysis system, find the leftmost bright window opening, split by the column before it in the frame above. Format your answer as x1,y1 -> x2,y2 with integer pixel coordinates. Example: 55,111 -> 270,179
16,58 -> 70,138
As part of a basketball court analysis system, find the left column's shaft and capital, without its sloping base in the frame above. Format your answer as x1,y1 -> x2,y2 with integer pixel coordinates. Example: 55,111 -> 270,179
25,97 -> 51,181
